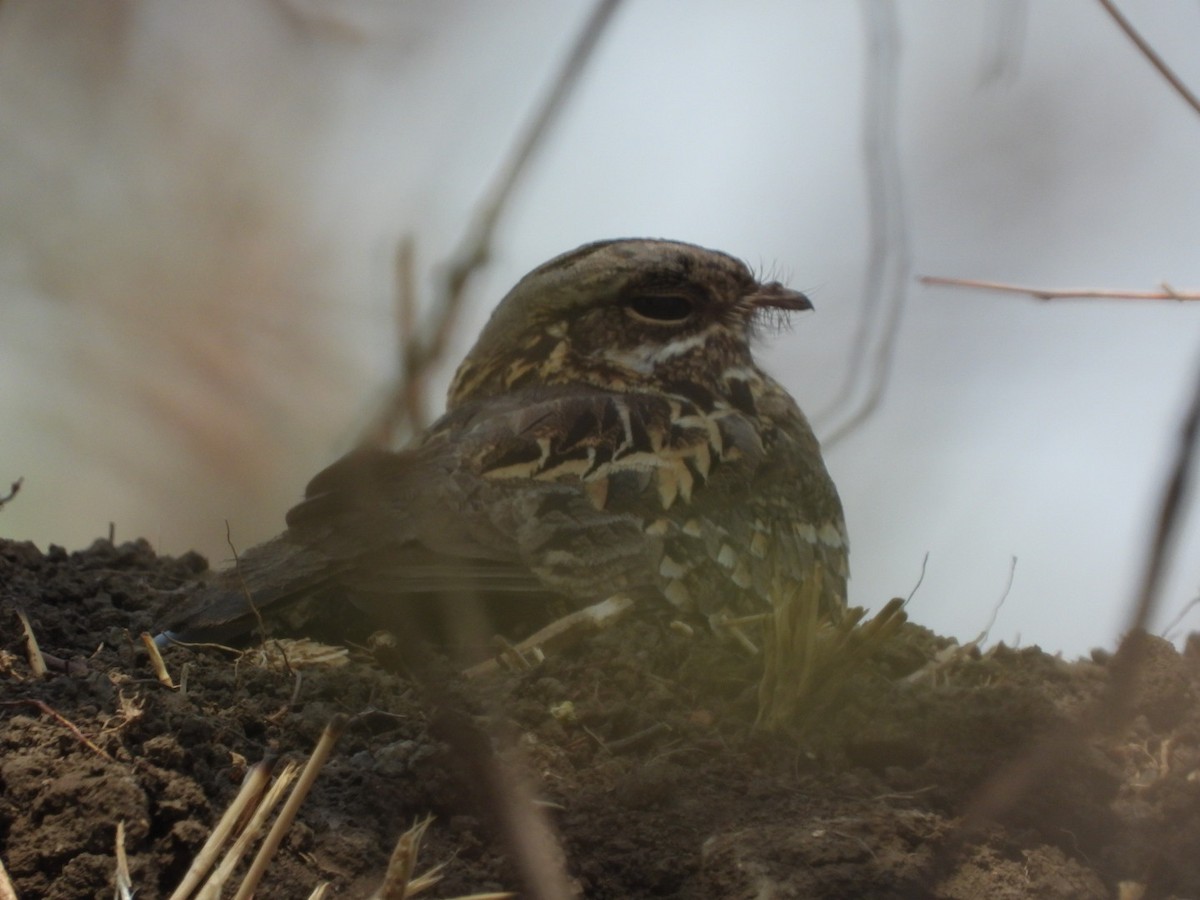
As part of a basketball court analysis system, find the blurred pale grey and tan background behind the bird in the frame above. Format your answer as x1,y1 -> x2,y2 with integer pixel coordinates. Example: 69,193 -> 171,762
0,0 -> 1200,655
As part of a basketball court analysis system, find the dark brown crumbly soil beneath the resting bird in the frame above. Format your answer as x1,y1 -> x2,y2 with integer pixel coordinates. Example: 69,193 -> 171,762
0,542 -> 1200,900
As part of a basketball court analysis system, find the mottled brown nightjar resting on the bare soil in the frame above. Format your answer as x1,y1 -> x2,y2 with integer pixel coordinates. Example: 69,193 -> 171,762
163,239 -> 848,720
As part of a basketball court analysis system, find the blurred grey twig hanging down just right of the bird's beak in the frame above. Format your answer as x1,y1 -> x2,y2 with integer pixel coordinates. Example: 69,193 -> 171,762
817,0 -> 912,446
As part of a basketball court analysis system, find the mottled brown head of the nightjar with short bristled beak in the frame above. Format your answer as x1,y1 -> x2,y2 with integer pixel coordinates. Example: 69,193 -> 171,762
449,239 -> 811,409
